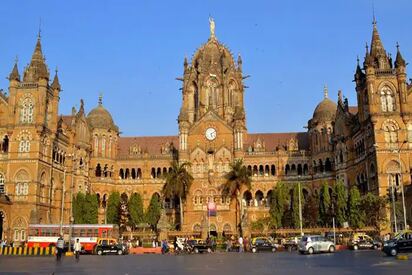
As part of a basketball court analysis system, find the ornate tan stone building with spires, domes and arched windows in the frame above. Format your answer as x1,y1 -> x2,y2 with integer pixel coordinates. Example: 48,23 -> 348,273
0,22 -> 412,241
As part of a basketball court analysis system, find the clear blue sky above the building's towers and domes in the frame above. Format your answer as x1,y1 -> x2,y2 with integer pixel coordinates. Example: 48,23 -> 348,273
0,0 -> 412,136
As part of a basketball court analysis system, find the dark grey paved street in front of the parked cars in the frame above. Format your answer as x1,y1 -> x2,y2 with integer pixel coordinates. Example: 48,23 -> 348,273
0,251 -> 412,275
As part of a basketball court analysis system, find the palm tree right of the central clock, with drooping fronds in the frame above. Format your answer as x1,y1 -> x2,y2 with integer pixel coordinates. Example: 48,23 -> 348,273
222,159 -> 252,237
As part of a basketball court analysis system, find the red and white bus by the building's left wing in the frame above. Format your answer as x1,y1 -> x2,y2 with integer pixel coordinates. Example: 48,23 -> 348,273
27,224 -> 119,253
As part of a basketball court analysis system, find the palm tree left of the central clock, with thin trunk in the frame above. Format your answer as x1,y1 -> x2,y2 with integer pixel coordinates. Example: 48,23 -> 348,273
162,160 -> 193,230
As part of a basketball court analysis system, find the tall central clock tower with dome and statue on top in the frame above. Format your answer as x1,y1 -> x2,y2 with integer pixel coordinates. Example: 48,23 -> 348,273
178,20 -> 247,233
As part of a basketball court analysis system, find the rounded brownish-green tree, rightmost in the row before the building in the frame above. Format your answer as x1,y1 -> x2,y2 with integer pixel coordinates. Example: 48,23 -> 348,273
360,193 -> 388,231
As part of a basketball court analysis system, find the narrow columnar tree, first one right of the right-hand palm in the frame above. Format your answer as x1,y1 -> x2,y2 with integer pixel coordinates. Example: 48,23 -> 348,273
270,182 -> 288,228
